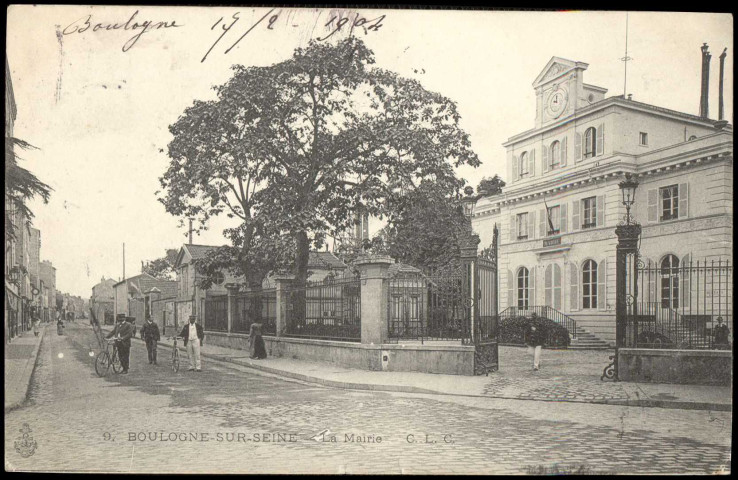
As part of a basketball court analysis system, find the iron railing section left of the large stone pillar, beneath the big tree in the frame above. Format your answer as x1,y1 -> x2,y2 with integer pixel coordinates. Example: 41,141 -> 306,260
285,273 -> 361,342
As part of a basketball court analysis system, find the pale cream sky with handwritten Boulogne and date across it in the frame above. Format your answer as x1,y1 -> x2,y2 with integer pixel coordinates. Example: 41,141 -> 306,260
7,5 -> 733,298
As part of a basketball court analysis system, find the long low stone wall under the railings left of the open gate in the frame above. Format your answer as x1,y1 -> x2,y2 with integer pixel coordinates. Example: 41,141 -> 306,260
205,332 -> 474,375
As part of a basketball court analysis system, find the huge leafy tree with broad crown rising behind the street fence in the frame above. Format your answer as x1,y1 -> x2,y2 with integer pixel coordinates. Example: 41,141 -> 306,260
161,37 -> 480,282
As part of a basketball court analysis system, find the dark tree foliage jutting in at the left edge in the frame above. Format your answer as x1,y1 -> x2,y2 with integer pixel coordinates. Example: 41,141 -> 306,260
5,137 -> 52,246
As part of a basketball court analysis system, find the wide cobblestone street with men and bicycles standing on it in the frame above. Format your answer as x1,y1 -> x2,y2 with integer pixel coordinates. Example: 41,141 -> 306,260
5,324 -> 731,474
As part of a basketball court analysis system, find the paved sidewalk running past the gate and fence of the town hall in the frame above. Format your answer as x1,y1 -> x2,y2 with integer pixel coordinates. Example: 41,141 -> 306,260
99,327 -> 732,411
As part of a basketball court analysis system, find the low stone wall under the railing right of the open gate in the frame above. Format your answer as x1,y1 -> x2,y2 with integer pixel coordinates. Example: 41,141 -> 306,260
618,348 -> 733,385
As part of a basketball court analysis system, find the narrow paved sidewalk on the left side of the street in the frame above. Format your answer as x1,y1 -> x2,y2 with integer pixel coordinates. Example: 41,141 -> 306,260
5,324 -> 46,412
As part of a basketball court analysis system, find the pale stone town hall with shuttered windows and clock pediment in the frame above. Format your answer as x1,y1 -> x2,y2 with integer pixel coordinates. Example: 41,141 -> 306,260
473,57 -> 733,345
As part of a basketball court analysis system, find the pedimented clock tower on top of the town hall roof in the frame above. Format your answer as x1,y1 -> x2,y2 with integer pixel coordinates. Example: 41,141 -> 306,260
533,57 -> 607,128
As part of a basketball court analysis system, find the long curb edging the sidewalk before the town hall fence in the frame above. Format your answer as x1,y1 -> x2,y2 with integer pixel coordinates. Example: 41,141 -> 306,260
100,328 -> 733,412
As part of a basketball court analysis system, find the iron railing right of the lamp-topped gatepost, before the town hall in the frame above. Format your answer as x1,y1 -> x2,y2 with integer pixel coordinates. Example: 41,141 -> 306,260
625,257 -> 733,349
